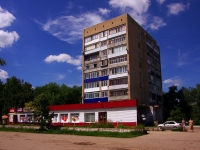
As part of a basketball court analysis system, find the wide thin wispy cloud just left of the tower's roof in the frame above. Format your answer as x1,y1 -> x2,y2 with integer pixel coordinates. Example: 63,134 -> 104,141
43,13 -> 104,43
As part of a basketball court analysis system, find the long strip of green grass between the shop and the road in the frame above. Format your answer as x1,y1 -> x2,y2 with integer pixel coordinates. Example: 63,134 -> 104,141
0,128 -> 145,138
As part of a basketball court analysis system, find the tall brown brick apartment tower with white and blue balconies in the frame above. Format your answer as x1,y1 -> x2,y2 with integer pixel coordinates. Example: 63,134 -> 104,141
82,14 -> 162,122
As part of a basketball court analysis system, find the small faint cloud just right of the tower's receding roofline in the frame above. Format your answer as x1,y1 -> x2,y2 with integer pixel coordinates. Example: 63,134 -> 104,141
149,16 -> 167,30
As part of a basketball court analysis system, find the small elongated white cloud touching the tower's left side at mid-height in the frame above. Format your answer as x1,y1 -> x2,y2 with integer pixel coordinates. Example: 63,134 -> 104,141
44,54 -> 82,66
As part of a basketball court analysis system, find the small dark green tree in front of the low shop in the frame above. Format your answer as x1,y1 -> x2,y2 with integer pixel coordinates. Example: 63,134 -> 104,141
30,94 -> 54,130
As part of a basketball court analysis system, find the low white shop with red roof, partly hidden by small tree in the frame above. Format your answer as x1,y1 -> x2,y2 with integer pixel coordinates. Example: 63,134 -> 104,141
8,100 -> 137,126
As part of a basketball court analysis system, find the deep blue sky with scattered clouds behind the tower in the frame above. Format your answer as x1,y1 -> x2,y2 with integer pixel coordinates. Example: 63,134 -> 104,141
0,0 -> 200,91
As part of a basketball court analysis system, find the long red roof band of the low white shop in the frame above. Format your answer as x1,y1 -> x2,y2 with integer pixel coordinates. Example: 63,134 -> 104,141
49,99 -> 137,111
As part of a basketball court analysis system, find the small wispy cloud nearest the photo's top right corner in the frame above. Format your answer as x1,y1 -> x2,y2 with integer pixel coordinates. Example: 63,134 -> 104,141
167,3 -> 190,15
